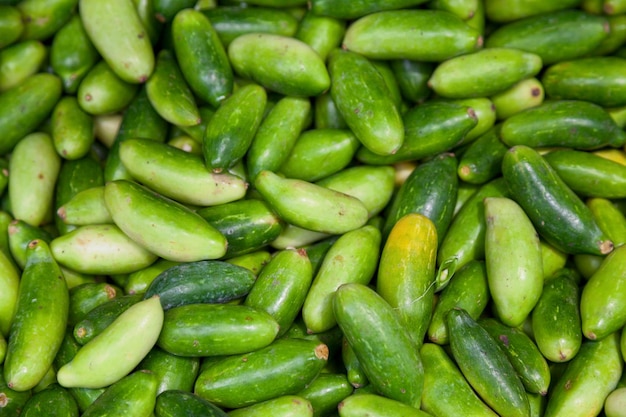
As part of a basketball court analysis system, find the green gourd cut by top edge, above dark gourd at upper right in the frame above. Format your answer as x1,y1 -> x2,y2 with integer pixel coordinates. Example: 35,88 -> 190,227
485,0 -> 580,22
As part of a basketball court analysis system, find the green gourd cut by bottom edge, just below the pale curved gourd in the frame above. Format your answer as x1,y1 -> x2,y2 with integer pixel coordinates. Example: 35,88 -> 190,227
82,370 -> 158,417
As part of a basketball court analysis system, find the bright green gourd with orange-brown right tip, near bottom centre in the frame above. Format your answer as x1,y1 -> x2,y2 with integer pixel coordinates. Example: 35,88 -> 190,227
194,339 -> 328,408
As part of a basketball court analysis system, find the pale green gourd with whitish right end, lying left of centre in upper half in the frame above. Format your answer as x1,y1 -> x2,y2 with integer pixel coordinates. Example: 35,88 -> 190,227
119,139 -> 247,206
